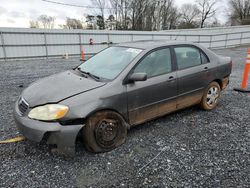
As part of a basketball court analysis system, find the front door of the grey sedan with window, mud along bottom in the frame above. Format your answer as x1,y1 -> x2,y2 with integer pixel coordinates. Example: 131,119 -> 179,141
126,48 -> 177,125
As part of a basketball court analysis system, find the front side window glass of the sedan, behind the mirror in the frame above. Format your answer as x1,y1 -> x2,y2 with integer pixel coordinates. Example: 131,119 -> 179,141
133,48 -> 172,78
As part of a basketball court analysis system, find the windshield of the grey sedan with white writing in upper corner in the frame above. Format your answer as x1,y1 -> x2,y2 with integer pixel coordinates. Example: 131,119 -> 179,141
78,47 -> 142,80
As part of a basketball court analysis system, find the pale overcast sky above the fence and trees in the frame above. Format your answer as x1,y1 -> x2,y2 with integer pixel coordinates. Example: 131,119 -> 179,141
0,0 -> 227,27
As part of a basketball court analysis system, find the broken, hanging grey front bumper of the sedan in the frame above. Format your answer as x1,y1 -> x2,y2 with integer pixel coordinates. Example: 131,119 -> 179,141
14,103 -> 84,156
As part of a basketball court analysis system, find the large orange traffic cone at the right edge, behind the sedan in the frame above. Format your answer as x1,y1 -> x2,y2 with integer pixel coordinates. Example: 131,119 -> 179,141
234,48 -> 250,92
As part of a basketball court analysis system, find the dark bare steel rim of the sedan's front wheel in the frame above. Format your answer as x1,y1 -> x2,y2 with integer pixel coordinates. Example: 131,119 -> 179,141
96,119 -> 118,147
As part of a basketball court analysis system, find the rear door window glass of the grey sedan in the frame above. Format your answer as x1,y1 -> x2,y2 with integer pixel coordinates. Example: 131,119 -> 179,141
174,47 -> 202,69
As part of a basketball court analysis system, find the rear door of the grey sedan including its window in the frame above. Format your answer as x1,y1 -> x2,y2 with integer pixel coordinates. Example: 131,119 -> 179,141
174,45 -> 209,109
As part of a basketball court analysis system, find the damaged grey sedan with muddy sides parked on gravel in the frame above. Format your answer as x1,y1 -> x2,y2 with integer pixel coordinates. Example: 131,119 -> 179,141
14,41 -> 232,155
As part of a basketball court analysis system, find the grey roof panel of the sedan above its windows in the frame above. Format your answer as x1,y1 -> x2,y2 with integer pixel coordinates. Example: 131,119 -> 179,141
116,40 -> 194,49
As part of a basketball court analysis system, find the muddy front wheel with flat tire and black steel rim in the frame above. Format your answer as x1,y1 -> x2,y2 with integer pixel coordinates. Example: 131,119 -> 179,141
82,111 -> 127,152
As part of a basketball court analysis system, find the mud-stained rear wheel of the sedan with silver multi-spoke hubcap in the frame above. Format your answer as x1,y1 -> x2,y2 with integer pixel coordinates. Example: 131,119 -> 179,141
200,82 -> 221,110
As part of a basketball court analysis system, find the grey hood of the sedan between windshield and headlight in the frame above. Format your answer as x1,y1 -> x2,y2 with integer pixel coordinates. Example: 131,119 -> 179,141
22,70 -> 106,107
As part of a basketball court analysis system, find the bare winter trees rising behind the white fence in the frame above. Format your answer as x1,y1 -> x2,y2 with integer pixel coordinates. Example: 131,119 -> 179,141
30,0 -> 250,31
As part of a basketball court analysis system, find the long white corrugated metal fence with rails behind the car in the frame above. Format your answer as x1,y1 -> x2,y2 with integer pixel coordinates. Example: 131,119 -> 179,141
0,26 -> 250,60
